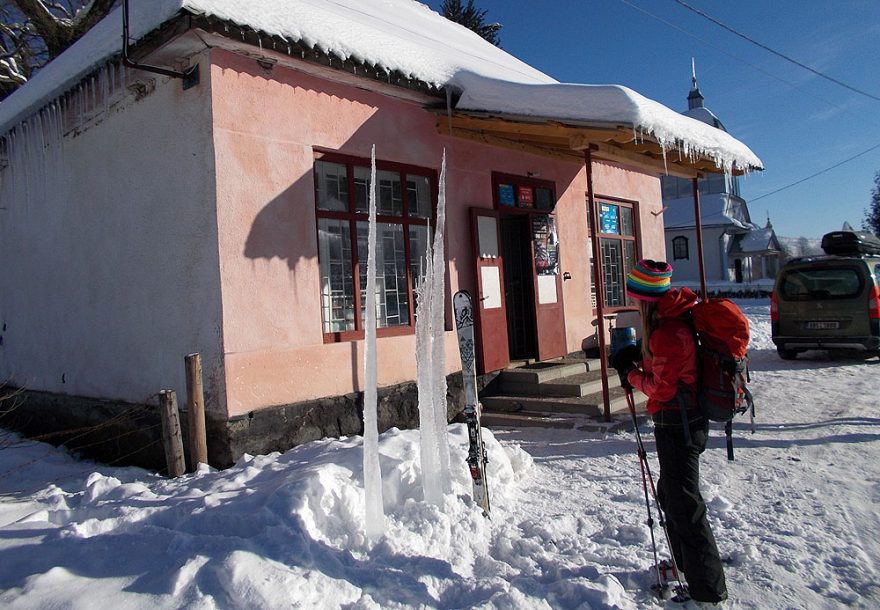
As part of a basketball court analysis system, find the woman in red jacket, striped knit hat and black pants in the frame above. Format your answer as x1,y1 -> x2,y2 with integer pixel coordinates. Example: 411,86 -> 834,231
615,260 -> 727,602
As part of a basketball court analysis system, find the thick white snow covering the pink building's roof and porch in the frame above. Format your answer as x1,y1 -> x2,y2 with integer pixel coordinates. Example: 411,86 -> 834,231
0,0 -> 763,170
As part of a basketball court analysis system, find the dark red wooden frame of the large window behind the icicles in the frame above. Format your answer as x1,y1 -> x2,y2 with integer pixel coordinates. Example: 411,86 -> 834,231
312,150 -> 439,343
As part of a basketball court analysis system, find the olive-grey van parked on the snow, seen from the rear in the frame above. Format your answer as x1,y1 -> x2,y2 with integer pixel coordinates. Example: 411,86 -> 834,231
770,255 -> 880,360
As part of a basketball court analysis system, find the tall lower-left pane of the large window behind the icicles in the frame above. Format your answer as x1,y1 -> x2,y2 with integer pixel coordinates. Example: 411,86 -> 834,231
318,218 -> 355,333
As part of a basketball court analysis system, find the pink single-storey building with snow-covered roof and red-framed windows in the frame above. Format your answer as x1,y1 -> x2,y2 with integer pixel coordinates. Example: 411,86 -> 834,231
0,0 -> 760,465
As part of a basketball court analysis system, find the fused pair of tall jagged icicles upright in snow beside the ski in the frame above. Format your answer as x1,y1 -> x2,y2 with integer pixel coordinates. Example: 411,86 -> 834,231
416,151 -> 452,506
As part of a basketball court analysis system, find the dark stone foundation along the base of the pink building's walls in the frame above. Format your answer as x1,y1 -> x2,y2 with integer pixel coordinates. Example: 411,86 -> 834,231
0,373 -> 495,472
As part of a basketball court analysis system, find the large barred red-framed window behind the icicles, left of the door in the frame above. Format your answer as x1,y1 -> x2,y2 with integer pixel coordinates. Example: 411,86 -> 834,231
315,154 -> 435,341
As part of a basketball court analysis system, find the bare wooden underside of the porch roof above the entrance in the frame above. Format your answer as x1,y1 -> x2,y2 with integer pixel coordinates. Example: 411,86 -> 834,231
437,109 -> 745,178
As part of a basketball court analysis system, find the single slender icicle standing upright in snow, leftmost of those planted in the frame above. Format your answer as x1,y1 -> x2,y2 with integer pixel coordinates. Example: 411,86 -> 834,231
364,145 -> 385,541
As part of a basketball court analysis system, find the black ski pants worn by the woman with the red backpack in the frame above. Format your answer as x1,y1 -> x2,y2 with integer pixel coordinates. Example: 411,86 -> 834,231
653,409 -> 727,602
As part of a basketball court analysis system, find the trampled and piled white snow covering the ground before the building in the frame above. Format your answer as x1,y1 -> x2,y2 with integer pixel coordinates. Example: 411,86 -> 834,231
0,300 -> 880,610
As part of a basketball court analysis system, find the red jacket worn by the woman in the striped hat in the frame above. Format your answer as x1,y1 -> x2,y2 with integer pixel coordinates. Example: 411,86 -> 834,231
627,288 -> 697,415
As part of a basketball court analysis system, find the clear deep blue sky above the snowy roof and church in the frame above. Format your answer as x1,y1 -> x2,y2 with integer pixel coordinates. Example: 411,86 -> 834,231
428,0 -> 880,237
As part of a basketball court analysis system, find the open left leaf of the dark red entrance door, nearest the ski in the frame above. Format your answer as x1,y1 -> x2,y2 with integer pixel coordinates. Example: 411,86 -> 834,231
471,208 -> 510,374
